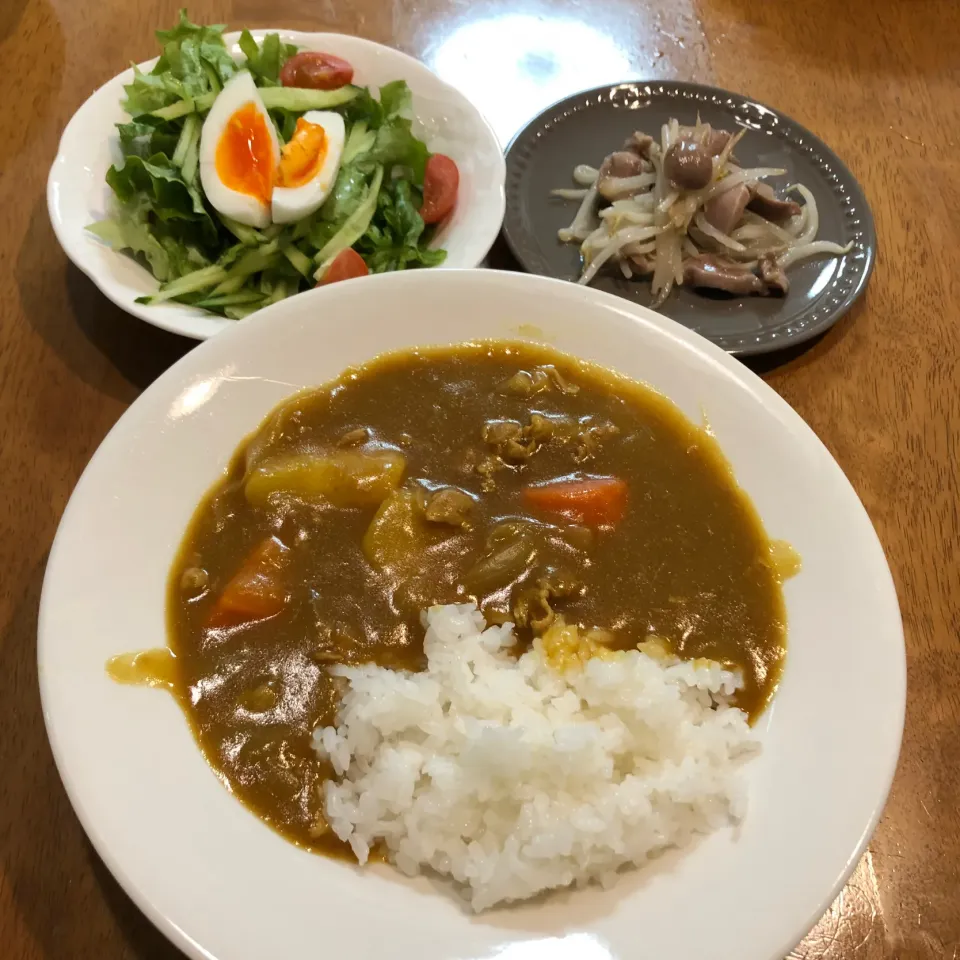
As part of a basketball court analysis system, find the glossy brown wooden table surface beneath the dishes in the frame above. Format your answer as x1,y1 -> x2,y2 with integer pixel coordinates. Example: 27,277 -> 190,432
0,0 -> 960,960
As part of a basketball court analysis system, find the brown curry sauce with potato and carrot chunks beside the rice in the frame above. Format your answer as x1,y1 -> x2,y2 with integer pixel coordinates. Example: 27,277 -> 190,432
112,343 -> 785,852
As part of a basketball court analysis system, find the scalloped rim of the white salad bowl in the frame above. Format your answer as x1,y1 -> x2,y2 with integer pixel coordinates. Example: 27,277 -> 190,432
45,27 -> 507,341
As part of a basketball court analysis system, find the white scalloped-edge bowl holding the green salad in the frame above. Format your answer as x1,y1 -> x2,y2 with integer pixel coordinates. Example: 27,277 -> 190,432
47,30 -> 506,340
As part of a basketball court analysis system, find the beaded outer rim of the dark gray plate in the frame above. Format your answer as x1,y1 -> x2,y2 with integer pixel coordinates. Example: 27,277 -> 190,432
501,78 -> 878,357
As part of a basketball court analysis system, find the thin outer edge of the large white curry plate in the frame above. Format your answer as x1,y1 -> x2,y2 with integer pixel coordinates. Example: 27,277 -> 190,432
37,269 -> 907,960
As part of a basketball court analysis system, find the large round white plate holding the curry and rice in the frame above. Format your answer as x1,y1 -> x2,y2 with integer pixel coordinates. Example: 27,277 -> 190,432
38,271 -> 906,960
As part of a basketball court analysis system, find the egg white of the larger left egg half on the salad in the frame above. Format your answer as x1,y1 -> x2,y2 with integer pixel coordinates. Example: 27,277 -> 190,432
200,70 -> 282,227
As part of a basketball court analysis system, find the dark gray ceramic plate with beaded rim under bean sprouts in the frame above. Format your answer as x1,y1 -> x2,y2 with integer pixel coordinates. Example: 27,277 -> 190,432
503,81 -> 877,355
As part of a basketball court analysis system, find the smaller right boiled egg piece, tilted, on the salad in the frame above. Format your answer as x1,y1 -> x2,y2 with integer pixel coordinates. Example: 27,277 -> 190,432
272,110 -> 345,223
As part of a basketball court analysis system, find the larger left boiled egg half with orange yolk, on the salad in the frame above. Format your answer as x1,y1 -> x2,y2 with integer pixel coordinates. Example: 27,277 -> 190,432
200,70 -> 280,227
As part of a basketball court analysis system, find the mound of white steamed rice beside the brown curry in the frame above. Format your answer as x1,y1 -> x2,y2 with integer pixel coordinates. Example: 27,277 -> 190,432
314,605 -> 758,910
